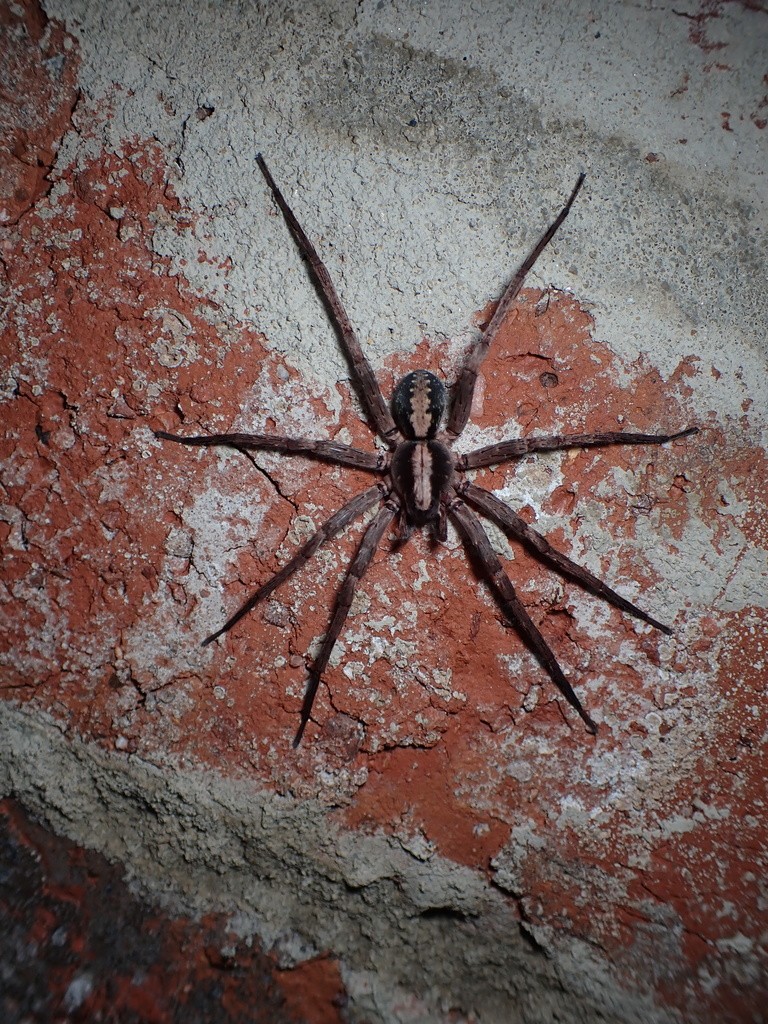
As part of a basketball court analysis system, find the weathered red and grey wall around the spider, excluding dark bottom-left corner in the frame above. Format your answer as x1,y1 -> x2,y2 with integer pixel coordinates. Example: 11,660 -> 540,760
0,0 -> 768,1021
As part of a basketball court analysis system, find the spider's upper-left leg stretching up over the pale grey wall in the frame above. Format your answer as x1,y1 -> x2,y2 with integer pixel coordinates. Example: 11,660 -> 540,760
256,154 -> 397,445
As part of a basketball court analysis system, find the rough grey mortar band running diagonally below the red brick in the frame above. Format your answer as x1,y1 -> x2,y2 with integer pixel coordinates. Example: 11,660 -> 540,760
0,703 -> 677,1024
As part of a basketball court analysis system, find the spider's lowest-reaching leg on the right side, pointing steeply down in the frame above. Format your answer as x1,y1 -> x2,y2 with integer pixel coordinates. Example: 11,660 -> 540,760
449,498 -> 597,735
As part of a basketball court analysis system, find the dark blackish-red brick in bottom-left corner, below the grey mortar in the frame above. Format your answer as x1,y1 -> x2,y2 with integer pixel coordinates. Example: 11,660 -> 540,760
0,801 -> 317,1024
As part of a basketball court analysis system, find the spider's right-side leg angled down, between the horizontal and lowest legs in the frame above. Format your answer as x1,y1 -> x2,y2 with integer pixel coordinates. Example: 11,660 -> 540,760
457,481 -> 672,636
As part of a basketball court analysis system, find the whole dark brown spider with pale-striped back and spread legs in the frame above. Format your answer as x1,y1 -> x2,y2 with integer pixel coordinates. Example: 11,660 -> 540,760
155,154 -> 698,748
